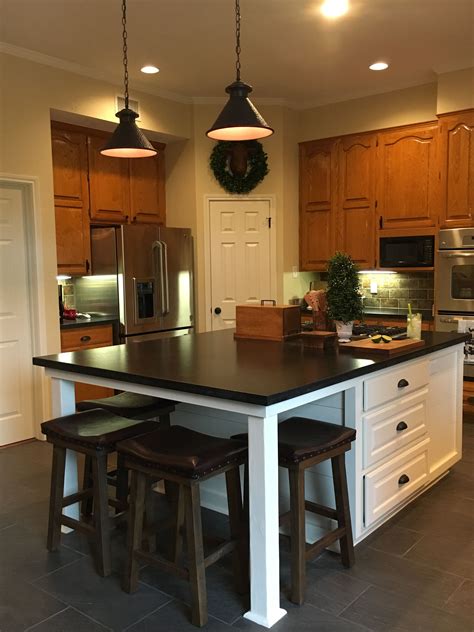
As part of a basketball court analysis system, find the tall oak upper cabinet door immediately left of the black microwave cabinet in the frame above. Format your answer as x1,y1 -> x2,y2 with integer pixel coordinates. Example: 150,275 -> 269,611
336,134 -> 377,268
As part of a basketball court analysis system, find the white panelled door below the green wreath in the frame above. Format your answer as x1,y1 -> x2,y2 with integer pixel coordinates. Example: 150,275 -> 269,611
209,200 -> 275,330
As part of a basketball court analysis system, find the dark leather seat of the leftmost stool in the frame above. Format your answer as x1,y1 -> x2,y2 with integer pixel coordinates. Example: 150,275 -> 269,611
41,408 -> 156,450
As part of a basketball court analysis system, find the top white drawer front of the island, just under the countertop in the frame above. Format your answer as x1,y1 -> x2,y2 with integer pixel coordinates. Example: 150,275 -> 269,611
364,360 -> 429,410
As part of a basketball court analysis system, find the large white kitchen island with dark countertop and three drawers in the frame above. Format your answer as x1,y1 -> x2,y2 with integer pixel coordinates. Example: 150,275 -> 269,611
34,330 -> 466,627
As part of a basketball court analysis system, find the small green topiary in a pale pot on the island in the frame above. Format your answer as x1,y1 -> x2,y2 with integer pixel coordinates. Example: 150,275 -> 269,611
326,252 -> 363,338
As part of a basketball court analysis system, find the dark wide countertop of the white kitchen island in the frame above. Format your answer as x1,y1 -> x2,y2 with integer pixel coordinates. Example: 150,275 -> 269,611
33,329 -> 467,406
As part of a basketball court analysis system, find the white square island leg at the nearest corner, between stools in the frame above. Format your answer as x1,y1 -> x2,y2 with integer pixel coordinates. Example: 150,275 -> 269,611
244,415 -> 286,628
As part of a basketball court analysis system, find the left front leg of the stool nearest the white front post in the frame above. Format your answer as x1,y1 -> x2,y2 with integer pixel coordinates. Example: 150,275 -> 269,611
123,470 -> 147,593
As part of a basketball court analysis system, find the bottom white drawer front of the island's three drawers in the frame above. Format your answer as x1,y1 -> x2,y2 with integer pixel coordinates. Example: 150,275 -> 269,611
364,439 -> 429,527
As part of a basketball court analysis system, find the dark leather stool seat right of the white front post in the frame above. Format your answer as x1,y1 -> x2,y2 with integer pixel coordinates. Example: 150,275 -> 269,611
232,417 -> 356,465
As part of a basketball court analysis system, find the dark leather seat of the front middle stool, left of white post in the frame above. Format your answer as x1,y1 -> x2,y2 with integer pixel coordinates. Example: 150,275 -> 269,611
117,426 -> 247,479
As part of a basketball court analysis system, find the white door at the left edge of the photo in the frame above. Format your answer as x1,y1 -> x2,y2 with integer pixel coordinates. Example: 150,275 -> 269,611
0,187 -> 34,445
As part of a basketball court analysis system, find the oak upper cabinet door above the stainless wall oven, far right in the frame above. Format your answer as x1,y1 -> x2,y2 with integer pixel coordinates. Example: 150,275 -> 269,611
439,110 -> 474,228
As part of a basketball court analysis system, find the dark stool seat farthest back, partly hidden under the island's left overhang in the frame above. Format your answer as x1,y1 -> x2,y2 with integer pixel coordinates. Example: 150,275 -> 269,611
76,392 -> 176,419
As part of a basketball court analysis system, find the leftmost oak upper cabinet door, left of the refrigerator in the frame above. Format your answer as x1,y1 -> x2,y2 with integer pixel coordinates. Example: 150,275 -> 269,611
51,127 -> 90,274
